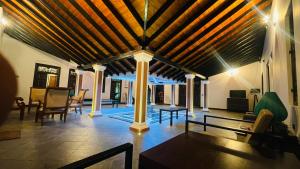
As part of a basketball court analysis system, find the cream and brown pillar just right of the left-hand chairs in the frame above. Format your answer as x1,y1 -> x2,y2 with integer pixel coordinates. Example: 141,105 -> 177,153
89,64 -> 106,117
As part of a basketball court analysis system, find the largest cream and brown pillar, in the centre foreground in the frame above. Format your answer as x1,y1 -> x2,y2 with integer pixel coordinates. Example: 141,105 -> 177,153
130,50 -> 153,132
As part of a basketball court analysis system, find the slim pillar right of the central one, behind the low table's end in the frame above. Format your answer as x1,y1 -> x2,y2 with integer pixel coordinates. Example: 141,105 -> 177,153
185,74 -> 195,116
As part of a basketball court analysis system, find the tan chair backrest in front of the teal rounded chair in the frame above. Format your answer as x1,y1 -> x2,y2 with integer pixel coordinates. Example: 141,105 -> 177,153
245,109 -> 273,142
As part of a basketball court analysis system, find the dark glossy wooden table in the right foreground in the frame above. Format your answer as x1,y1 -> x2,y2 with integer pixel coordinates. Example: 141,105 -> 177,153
139,132 -> 300,169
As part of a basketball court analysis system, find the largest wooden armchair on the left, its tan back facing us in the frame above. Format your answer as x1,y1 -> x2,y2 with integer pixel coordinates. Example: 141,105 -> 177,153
35,88 -> 70,125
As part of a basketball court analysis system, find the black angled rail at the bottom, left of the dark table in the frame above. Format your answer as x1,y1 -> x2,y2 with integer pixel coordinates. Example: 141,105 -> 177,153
60,143 -> 133,169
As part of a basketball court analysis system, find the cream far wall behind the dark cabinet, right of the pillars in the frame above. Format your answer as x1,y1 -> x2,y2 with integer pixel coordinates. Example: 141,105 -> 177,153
207,62 -> 261,110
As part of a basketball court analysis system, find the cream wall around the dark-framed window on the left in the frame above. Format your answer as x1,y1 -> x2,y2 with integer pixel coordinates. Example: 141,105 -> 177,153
1,34 -> 77,103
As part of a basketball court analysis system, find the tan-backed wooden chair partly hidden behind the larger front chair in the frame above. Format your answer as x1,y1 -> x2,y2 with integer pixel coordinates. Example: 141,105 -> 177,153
28,87 -> 46,113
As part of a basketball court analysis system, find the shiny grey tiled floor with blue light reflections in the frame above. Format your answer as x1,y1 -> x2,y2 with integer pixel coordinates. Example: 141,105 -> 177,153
0,106 -> 242,169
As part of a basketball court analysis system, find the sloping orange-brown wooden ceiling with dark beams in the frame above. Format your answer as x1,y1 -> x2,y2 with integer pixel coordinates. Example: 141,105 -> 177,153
1,0 -> 271,81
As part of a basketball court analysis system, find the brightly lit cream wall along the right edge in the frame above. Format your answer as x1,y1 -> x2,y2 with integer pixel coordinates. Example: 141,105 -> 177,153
261,0 -> 300,125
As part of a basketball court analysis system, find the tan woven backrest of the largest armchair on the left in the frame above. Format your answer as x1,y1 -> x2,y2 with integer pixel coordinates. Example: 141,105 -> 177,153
44,88 -> 70,109
